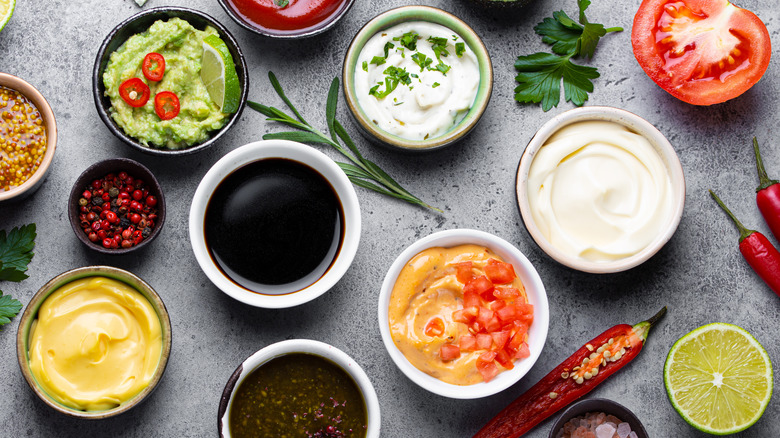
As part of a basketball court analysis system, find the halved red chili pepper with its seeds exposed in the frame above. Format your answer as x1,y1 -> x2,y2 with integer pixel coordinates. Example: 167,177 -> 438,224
474,307 -> 666,438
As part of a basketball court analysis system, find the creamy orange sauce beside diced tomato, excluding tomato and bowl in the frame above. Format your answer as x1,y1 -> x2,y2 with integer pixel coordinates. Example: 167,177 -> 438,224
388,245 -> 527,385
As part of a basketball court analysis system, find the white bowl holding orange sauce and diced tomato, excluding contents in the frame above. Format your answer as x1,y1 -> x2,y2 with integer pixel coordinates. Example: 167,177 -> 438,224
379,229 -> 550,399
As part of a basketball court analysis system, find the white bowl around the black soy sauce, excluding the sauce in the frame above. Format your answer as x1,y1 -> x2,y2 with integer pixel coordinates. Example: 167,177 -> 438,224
190,140 -> 361,309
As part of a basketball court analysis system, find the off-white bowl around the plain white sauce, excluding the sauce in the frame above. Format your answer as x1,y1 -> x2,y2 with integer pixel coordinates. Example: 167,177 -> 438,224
515,106 -> 685,274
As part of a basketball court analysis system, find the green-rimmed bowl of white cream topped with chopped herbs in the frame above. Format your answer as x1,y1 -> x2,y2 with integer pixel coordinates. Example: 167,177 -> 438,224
343,6 -> 493,151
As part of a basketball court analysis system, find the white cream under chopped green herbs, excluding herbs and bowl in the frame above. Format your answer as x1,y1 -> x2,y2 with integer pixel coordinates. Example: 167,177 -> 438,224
355,21 -> 479,140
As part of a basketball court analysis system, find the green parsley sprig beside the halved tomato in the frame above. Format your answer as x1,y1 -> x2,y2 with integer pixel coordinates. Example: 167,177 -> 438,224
515,0 -> 623,111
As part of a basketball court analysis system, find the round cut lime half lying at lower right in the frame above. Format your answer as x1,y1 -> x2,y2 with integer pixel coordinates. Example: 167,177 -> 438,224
664,322 -> 772,435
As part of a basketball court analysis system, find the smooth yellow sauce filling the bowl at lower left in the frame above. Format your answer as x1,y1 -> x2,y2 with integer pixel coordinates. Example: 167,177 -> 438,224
29,277 -> 162,411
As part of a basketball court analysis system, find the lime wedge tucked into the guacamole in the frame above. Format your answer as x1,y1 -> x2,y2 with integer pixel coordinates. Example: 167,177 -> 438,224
201,34 -> 241,113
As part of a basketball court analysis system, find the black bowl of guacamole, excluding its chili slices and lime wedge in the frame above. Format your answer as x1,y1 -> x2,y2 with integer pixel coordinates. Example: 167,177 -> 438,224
92,7 -> 249,155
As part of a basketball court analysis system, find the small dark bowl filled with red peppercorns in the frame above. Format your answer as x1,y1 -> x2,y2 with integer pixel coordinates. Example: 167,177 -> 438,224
68,158 -> 165,254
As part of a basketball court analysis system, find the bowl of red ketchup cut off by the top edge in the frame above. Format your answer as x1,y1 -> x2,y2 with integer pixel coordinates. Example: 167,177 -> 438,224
219,0 -> 355,39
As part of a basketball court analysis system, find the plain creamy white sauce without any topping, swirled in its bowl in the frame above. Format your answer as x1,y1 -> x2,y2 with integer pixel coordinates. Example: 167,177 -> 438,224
528,121 -> 673,262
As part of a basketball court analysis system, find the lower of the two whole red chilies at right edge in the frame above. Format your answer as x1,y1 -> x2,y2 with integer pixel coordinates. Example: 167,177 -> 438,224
710,190 -> 780,296
